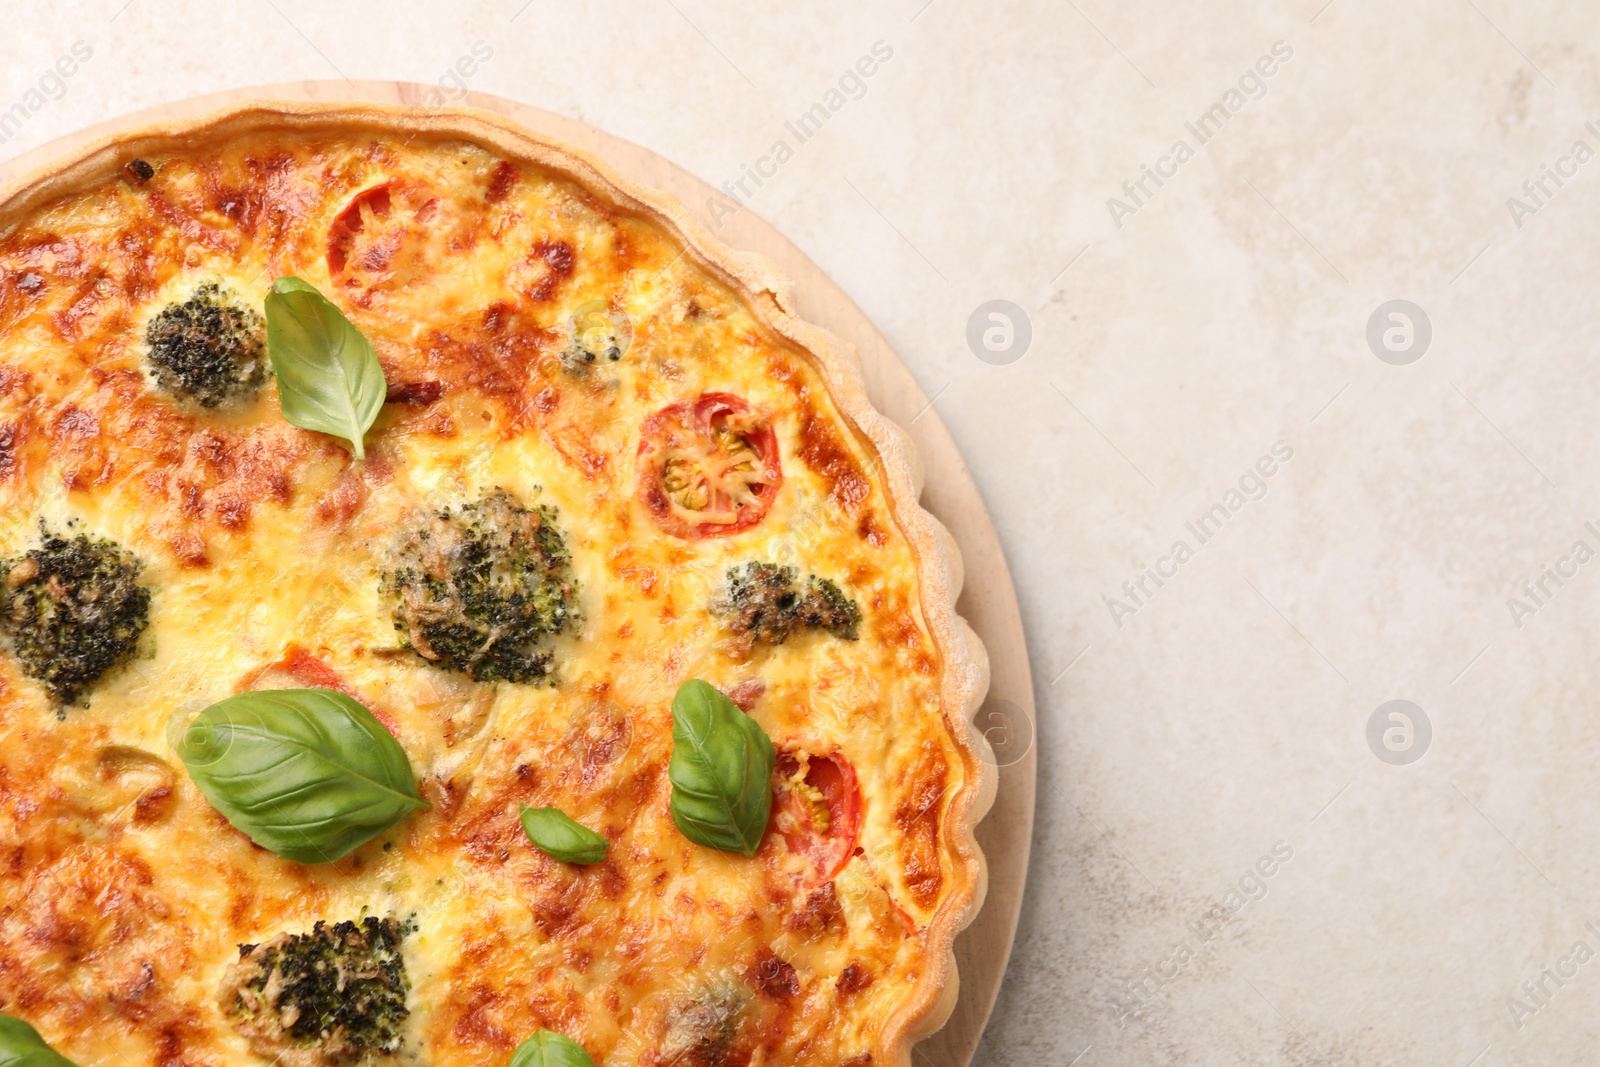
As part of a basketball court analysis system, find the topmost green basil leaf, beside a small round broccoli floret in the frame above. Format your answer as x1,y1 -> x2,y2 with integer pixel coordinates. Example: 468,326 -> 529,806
266,278 -> 389,459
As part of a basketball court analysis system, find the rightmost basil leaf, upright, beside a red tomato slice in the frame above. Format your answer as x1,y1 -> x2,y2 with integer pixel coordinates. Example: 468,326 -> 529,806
667,678 -> 776,856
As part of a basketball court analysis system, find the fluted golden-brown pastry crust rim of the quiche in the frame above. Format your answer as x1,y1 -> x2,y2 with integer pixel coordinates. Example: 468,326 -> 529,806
0,102 -> 997,1064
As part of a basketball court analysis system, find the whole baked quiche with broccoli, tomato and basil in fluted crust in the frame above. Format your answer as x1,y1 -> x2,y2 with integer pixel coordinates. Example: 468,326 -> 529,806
0,102 -> 994,1067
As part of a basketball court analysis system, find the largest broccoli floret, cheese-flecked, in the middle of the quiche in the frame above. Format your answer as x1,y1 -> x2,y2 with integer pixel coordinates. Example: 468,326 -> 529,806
381,490 -> 578,685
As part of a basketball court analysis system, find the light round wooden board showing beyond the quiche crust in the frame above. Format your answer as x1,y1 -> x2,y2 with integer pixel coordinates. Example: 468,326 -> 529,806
0,80 -> 1037,1067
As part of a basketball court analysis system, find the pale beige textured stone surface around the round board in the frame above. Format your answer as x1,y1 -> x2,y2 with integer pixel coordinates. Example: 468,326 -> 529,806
0,0 -> 1600,1067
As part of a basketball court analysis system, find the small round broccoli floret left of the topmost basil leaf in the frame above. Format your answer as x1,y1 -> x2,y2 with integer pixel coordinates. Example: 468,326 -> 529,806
144,283 -> 267,408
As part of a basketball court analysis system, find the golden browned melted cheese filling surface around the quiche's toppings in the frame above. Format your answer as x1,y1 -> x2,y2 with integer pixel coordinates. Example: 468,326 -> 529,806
0,134 -> 965,1067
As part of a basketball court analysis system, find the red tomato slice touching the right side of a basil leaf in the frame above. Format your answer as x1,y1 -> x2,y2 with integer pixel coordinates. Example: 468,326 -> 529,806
771,749 -> 861,881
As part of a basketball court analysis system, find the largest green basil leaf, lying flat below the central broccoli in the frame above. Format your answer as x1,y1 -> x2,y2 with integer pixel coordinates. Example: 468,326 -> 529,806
178,689 -> 427,864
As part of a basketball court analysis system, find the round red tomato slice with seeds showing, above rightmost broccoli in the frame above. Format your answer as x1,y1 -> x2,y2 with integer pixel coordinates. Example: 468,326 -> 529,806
638,392 -> 784,537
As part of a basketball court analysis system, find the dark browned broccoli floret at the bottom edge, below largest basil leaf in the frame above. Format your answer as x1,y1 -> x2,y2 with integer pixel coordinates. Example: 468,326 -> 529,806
218,915 -> 413,1067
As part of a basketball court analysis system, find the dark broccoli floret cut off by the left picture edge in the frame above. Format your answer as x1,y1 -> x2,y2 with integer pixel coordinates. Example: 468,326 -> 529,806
0,523 -> 150,704
